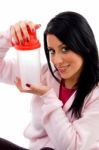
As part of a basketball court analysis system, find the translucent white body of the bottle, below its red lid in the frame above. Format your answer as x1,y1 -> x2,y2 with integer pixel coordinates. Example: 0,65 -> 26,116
17,48 -> 40,89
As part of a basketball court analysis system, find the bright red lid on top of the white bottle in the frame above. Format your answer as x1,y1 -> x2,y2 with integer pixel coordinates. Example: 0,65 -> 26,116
13,26 -> 41,51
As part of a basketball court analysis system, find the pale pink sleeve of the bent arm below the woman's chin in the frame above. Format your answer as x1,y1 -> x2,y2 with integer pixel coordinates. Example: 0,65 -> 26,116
41,87 -> 99,150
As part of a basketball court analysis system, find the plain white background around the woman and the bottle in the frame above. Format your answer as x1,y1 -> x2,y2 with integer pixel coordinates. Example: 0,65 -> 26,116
0,0 -> 99,147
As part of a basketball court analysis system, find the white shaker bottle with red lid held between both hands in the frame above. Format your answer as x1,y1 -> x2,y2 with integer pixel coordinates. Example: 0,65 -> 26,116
14,27 -> 40,89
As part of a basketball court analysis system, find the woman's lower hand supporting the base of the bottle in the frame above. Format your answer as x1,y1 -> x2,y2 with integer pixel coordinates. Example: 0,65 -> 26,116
15,78 -> 51,96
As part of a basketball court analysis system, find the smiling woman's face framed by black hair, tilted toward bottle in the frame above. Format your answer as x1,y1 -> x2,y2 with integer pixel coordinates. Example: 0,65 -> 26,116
47,34 -> 83,85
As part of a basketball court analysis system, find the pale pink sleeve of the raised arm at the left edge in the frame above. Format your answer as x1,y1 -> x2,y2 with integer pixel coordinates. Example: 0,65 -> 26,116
0,30 -> 18,84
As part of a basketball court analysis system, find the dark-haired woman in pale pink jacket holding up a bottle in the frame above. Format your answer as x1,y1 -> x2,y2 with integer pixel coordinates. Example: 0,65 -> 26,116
0,12 -> 99,150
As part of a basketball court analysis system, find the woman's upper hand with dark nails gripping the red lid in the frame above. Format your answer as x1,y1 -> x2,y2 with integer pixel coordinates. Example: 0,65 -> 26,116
10,21 -> 41,44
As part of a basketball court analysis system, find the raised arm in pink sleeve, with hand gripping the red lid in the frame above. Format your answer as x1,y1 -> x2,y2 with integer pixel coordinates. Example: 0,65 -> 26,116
0,21 -> 39,84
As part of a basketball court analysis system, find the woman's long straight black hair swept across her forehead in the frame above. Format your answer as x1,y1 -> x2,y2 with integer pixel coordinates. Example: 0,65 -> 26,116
44,12 -> 99,118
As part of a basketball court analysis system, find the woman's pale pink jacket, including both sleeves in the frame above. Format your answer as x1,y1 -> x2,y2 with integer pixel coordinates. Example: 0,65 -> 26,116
0,29 -> 99,150
